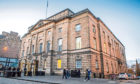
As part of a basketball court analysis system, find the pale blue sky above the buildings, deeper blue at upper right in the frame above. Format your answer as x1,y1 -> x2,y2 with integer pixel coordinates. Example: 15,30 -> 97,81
0,0 -> 140,64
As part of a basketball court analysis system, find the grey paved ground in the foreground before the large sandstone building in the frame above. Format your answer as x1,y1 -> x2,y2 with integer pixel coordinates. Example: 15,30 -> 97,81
0,76 -> 140,84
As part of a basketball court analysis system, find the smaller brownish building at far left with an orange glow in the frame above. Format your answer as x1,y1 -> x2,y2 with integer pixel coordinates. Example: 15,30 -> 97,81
0,31 -> 21,66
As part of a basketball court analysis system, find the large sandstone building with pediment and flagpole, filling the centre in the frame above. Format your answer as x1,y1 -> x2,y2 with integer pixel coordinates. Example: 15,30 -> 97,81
20,9 -> 126,76
